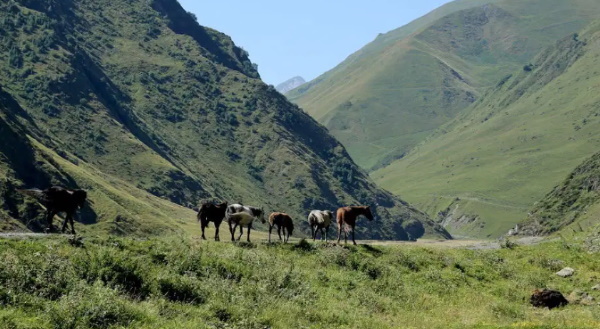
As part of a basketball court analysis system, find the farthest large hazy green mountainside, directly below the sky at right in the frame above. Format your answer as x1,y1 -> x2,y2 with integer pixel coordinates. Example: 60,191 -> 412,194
288,0 -> 600,170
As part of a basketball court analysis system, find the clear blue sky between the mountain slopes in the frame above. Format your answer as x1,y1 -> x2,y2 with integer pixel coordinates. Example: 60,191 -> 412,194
180,0 -> 449,85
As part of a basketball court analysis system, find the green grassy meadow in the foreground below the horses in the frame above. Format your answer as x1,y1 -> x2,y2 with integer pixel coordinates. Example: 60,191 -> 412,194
0,236 -> 600,328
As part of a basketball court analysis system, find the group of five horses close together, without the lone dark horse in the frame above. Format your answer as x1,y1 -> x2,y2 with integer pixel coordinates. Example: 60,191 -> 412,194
197,202 -> 373,244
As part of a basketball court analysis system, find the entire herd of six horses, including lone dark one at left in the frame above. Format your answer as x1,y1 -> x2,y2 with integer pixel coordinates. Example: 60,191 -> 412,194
18,186 -> 373,244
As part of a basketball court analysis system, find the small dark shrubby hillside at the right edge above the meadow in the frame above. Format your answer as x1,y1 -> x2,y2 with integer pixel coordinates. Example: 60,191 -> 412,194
518,153 -> 600,235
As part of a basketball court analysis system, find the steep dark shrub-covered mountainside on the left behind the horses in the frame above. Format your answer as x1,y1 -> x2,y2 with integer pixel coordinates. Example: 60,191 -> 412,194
0,0 -> 447,239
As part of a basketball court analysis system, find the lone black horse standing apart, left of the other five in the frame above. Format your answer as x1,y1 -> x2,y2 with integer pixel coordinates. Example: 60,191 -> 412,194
19,186 -> 87,234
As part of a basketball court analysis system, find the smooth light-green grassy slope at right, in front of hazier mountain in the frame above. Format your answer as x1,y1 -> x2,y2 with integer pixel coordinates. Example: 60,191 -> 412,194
372,24 -> 600,236
